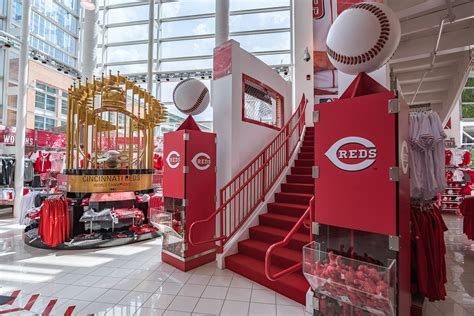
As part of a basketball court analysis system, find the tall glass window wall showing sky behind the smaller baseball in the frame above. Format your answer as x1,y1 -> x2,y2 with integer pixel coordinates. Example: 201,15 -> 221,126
98,0 -> 291,122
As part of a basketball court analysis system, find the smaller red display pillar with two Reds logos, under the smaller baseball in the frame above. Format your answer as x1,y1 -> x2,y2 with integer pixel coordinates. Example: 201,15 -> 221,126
161,116 -> 216,271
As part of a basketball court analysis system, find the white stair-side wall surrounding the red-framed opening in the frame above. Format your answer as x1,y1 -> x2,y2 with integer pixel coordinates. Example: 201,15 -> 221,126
211,40 -> 292,193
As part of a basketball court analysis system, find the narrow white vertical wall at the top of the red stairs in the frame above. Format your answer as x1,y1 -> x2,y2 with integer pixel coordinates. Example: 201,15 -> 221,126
293,0 -> 314,126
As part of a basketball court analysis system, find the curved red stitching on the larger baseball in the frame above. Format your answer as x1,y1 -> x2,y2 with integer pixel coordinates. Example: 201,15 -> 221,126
327,3 -> 390,65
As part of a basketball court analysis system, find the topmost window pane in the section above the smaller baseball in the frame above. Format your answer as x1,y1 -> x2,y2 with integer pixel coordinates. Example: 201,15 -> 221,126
160,0 -> 216,18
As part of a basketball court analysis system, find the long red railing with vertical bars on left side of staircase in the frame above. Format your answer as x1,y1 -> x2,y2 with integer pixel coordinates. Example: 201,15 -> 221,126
189,95 -> 308,252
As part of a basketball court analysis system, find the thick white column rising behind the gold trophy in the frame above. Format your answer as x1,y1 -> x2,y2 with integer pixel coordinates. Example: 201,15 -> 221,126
82,0 -> 99,80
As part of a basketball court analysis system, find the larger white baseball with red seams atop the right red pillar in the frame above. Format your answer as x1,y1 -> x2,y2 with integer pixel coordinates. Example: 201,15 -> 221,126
326,2 -> 401,75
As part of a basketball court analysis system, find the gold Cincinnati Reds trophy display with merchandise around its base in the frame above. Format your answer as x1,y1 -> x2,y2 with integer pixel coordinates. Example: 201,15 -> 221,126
24,74 -> 166,250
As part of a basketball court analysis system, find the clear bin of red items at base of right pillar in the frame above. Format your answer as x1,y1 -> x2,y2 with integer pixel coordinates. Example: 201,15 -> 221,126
303,242 -> 397,315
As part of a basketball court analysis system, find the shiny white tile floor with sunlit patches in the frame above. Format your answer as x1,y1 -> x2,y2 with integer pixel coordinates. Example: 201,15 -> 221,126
0,219 -> 309,316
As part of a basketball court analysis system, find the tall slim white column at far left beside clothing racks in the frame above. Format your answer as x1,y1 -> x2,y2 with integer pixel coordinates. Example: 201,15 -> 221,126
13,0 -> 31,218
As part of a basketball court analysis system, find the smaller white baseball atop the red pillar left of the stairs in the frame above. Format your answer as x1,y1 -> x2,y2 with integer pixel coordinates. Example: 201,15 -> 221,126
173,78 -> 209,115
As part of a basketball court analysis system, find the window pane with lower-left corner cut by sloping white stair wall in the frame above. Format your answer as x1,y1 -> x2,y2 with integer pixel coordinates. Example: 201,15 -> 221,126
232,32 -> 291,52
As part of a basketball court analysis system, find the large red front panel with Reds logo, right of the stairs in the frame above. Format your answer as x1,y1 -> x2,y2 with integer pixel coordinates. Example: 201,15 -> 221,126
315,92 -> 397,235
